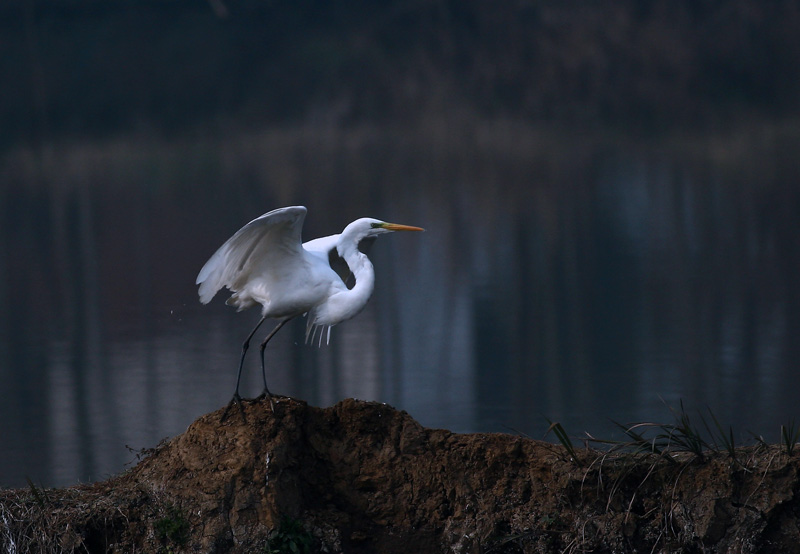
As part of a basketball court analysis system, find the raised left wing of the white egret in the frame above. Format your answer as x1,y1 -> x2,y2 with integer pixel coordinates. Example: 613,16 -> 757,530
196,206 -> 306,304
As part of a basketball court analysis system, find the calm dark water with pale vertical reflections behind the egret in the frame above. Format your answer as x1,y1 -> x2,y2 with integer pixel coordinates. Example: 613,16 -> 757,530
0,121 -> 800,487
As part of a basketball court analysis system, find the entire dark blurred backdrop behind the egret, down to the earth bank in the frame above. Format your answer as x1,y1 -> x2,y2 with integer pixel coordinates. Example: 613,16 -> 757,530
0,0 -> 800,486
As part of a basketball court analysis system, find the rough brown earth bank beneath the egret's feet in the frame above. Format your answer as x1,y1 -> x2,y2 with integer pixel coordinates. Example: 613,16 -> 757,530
0,398 -> 800,554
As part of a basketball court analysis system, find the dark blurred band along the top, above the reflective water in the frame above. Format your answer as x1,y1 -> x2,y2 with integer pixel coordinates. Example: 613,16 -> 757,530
6,0 -> 800,144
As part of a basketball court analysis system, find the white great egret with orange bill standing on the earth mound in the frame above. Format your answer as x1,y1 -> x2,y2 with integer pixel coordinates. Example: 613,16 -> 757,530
196,206 -> 423,420
